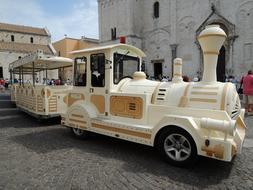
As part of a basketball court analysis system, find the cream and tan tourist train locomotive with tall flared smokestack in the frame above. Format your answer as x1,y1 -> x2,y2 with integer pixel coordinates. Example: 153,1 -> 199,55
61,25 -> 246,166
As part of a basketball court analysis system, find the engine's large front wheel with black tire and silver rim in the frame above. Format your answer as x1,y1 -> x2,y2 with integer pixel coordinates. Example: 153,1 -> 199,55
156,126 -> 198,167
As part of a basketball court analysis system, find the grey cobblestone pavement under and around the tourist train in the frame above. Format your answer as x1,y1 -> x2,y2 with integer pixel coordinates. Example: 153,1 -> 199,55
0,91 -> 253,190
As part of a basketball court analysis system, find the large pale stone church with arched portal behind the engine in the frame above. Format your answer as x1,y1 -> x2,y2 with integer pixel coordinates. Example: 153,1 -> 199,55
98,0 -> 253,81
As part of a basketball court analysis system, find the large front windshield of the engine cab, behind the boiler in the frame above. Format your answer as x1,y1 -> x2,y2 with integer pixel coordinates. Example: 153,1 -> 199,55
113,53 -> 140,84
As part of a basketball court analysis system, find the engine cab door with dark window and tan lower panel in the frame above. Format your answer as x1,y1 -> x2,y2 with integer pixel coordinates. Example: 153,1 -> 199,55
90,53 -> 106,116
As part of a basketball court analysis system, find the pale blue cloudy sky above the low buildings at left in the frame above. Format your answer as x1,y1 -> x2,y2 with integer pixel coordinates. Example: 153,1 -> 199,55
0,0 -> 98,41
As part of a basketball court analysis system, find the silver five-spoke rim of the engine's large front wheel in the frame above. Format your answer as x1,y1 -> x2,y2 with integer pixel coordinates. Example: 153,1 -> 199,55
164,134 -> 191,161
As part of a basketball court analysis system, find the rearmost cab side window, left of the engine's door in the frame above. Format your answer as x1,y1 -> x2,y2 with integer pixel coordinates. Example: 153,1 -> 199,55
74,57 -> 87,86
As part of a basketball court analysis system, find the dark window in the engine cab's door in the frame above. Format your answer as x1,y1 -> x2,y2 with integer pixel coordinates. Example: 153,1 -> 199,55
90,53 -> 105,87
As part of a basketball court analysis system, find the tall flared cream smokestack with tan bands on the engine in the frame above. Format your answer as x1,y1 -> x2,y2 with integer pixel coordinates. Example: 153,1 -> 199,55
198,25 -> 227,82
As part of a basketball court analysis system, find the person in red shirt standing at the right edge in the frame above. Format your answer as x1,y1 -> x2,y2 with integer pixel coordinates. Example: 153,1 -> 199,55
241,70 -> 253,114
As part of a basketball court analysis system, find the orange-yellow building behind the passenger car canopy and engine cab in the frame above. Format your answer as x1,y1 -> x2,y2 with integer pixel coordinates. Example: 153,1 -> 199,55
53,37 -> 99,80
